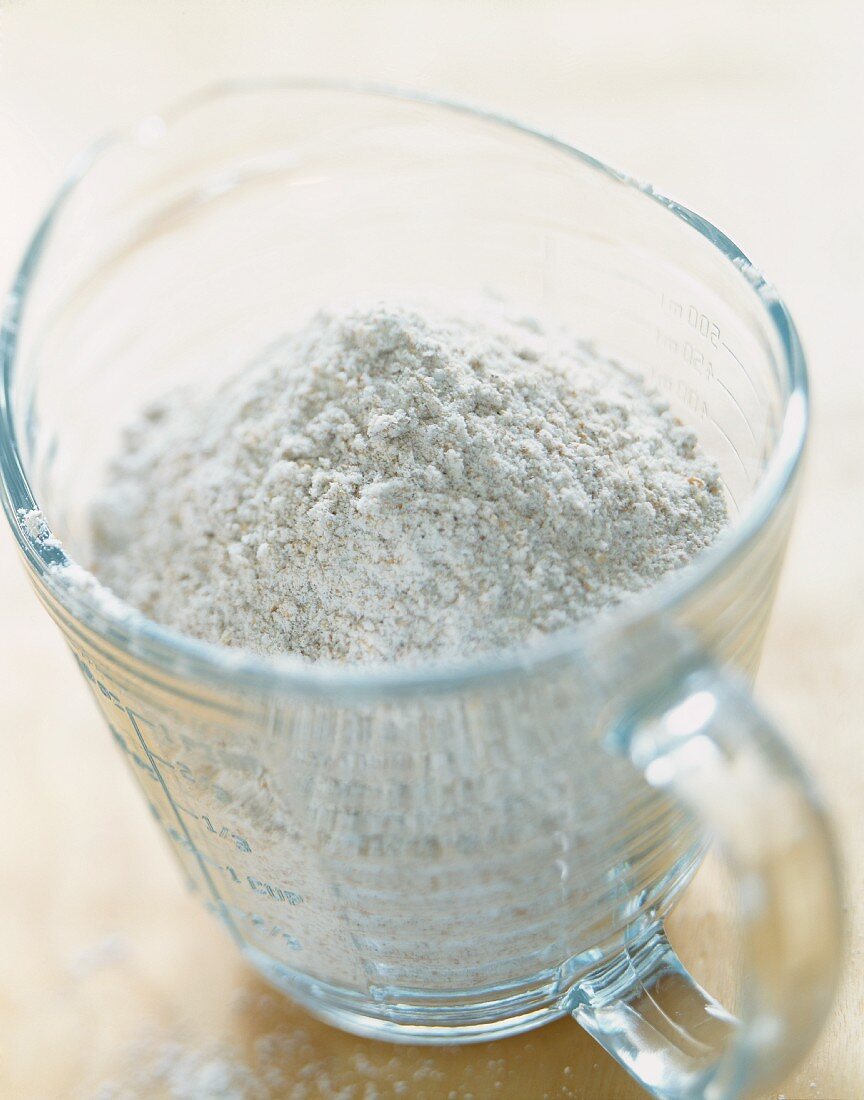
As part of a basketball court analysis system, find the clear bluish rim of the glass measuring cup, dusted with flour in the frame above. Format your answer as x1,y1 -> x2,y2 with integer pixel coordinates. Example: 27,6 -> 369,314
0,77 -> 809,696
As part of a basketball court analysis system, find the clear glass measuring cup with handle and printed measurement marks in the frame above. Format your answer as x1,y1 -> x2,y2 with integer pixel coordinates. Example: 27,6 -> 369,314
0,81 -> 840,1098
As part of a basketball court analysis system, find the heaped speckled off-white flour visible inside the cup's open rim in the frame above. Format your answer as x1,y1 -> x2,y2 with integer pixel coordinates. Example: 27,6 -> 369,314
92,305 -> 726,662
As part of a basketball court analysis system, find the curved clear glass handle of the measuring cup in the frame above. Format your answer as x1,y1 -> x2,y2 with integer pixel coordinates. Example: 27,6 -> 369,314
572,668 -> 842,1100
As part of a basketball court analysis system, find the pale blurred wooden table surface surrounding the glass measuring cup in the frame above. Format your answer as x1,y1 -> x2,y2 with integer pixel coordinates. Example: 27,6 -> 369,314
0,0 -> 864,1100
